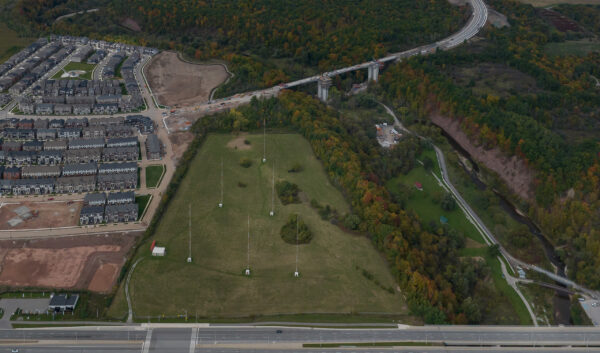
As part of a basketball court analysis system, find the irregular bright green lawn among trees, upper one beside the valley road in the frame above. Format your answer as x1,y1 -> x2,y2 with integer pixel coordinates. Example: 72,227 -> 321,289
386,150 -> 485,244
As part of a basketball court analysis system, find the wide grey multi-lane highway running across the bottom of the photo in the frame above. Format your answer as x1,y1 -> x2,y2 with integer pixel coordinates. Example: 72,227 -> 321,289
0,326 -> 600,346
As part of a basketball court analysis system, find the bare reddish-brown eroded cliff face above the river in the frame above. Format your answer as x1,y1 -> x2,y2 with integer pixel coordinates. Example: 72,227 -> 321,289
430,113 -> 535,200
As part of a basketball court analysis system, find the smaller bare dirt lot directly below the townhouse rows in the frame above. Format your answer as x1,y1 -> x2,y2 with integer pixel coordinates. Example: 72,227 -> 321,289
0,201 -> 82,230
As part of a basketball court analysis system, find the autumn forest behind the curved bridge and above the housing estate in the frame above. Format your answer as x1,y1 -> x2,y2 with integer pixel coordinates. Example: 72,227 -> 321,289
4,0 -> 469,96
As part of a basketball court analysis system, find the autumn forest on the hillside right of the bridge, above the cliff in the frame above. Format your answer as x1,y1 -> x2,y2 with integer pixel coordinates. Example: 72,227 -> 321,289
379,0 -> 600,289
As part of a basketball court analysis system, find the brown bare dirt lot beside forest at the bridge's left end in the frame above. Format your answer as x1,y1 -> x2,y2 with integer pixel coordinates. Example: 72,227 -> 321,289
144,52 -> 228,106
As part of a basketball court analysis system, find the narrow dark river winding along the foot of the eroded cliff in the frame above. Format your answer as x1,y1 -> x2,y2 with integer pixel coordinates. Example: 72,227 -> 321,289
440,128 -> 571,325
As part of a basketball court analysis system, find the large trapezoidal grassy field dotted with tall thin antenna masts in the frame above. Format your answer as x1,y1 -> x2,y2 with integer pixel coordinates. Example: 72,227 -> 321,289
110,134 -> 414,322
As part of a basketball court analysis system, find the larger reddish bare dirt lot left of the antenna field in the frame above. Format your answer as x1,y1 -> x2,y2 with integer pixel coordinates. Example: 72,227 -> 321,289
0,233 -> 140,292
